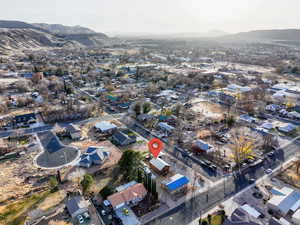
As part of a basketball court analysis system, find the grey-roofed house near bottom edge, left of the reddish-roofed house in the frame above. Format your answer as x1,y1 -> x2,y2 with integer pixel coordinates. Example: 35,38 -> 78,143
66,196 -> 89,218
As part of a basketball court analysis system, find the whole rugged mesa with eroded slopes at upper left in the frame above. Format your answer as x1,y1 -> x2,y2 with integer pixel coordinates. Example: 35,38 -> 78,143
0,20 -> 110,54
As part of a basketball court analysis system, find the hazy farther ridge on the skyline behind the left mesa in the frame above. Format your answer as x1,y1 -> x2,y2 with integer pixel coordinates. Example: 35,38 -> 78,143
32,23 -> 96,34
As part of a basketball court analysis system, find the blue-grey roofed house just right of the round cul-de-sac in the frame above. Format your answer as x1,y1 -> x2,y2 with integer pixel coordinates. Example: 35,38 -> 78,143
79,146 -> 110,168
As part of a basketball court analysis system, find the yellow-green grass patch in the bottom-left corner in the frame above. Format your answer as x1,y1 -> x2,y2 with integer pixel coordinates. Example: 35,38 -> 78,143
0,191 -> 50,225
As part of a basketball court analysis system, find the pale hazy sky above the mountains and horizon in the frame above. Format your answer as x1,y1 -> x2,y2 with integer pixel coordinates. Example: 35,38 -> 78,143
0,0 -> 300,34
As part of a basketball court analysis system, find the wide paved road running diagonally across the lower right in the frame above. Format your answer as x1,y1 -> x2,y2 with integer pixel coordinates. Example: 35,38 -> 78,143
148,137 -> 300,225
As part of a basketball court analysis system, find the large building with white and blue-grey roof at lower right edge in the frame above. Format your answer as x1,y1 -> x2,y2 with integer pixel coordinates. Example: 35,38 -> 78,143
267,187 -> 300,215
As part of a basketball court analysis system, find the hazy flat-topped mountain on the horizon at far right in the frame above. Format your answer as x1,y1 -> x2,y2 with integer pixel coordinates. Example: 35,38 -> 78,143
222,29 -> 300,41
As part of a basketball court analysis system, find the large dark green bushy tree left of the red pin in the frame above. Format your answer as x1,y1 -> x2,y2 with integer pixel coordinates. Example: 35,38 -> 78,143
119,149 -> 144,181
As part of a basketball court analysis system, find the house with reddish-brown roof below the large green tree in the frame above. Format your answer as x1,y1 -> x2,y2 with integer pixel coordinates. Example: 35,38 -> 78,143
107,183 -> 148,209
